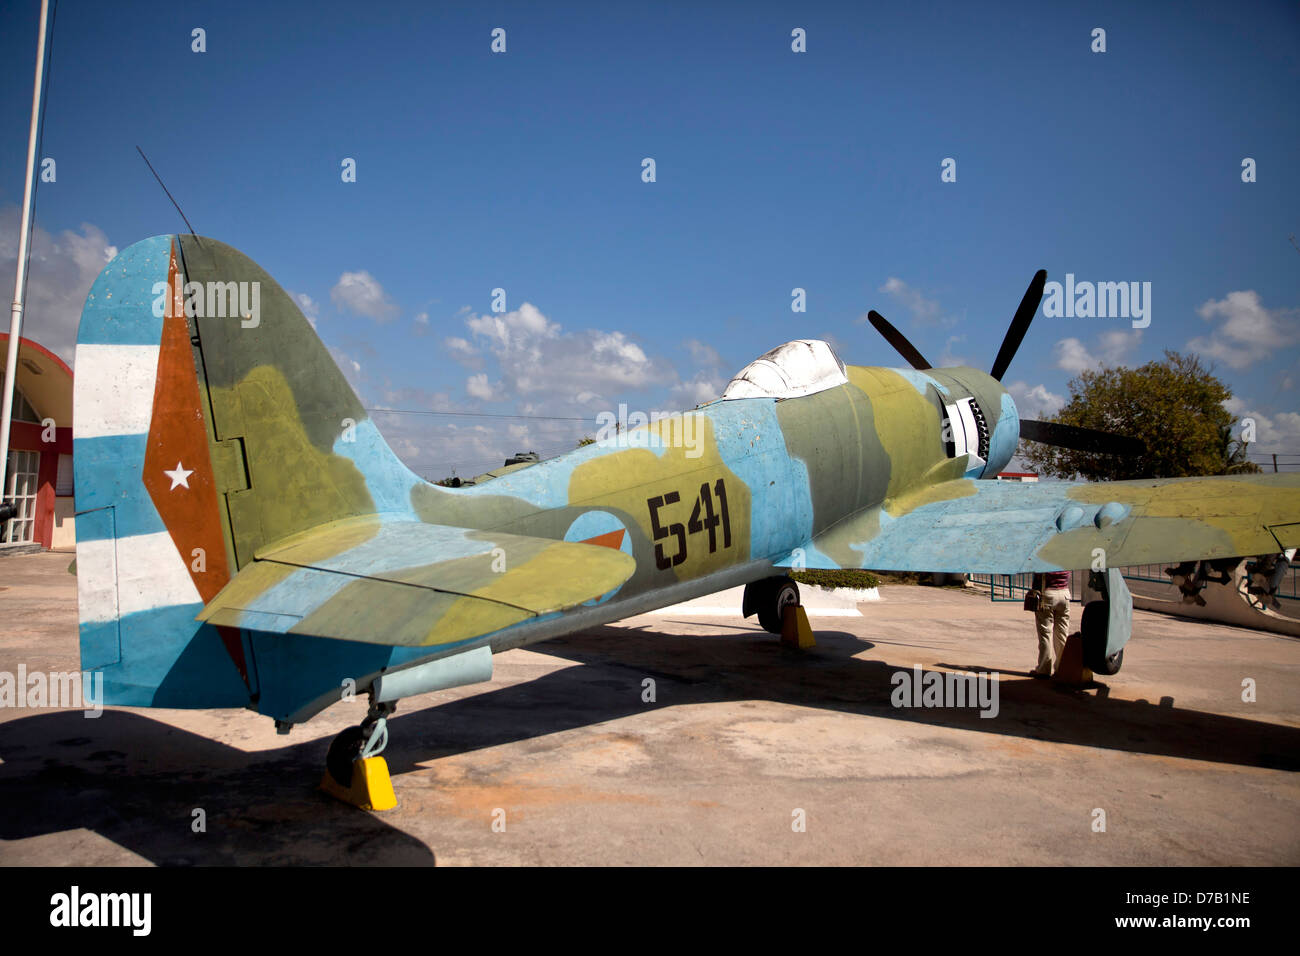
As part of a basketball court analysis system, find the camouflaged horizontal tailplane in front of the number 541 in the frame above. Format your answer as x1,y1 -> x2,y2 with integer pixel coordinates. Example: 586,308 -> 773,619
198,516 -> 636,646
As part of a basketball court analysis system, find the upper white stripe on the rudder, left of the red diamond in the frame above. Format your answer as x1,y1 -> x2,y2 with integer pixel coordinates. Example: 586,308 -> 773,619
73,343 -> 159,438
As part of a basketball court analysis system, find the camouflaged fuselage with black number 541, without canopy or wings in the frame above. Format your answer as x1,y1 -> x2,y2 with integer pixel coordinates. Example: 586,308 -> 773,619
400,367 -> 1018,646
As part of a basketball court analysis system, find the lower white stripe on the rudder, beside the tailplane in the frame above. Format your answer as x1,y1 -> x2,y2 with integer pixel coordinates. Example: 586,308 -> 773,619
77,531 -> 203,623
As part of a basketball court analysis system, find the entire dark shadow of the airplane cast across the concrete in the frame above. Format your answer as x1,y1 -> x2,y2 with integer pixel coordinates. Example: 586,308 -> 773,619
0,626 -> 1300,865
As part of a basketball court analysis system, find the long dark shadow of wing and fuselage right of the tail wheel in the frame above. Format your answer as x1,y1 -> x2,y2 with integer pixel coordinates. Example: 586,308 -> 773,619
387,626 -> 1300,773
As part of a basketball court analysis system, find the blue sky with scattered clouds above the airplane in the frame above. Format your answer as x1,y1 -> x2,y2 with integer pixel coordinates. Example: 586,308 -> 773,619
0,0 -> 1300,477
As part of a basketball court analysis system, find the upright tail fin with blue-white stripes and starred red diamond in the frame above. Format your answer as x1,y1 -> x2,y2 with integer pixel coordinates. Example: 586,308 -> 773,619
73,235 -> 420,706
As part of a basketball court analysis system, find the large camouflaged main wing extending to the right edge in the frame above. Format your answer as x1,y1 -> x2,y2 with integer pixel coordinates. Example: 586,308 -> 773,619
779,473 -> 1300,574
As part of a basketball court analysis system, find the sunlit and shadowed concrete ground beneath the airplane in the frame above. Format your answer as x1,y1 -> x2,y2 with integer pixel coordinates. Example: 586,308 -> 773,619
0,554 -> 1300,865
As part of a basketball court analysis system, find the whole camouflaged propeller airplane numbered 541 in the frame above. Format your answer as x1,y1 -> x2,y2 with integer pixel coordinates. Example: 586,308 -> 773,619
73,234 -> 1300,806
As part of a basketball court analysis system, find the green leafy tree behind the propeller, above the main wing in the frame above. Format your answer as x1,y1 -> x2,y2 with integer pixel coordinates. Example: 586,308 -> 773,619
1021,351 -> 1258,481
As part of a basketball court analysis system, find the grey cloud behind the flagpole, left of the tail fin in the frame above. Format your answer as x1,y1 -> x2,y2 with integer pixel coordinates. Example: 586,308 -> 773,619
0,206 -> 117,361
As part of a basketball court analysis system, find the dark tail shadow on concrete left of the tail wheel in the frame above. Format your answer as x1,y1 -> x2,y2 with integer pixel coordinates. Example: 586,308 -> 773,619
0,710 -> 436,866
